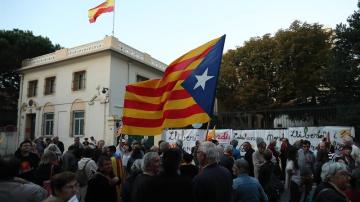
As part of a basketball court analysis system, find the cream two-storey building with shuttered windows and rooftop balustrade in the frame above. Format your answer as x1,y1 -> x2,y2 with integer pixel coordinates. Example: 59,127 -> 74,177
17,36 -> 166,146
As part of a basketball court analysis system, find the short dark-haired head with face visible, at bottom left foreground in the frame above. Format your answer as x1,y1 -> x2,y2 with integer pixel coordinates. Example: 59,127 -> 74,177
51,171 -> 79,201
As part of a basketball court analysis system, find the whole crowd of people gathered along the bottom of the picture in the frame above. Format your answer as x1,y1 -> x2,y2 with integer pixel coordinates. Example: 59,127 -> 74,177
0,136 -> 360,202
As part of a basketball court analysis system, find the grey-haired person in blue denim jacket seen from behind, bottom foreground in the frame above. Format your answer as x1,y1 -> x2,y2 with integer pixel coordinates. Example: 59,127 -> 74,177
232,159 -> 268,202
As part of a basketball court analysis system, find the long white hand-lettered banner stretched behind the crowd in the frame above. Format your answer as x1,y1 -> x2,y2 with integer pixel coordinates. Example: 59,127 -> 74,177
164,126 -> 355,153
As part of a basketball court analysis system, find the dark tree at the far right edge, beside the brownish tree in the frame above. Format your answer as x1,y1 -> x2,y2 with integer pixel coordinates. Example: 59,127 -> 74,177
327,3 -> 360,104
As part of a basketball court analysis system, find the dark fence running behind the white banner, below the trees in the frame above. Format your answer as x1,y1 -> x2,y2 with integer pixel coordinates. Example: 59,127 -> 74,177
210,105 -> 360,140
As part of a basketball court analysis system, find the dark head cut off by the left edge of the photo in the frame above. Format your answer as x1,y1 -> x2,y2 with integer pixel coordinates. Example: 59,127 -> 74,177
0,156 -> 20,179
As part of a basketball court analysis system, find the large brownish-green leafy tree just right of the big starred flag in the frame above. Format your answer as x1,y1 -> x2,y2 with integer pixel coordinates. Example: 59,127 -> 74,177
218,21 -> 331,110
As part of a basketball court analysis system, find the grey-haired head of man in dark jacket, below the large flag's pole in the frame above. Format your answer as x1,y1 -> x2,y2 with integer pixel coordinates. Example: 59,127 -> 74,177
196,141 -> 219,166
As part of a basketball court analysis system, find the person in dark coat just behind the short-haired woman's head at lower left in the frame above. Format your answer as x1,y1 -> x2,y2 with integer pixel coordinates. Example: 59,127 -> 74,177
34,151 -> 62,186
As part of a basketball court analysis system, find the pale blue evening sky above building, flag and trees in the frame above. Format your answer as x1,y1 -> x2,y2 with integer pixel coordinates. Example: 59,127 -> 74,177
0,0 -> 358,64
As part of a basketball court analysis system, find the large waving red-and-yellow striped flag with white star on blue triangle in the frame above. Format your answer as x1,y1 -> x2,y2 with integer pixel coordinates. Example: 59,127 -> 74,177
121,35 -> 225,135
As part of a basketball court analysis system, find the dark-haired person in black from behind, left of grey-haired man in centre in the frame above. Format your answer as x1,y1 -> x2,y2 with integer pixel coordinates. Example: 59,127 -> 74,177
147,148 -> 192,202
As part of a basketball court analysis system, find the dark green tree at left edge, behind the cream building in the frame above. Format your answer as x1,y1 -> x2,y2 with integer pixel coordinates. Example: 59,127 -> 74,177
0,29 -> 60,125
